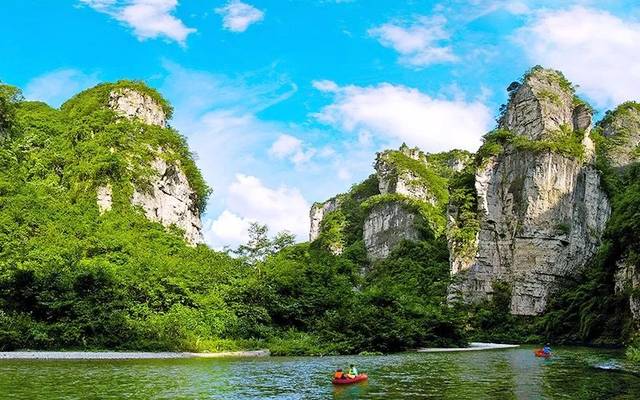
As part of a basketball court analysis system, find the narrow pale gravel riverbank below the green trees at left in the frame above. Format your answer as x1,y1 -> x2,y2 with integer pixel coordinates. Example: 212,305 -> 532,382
0,349 -> 271,360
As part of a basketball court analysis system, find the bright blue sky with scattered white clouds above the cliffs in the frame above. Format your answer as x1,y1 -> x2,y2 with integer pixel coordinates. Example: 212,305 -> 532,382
0,0 -> 640,248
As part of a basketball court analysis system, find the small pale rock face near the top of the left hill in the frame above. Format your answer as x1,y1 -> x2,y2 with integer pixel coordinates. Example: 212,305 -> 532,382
109,88 -> 167,128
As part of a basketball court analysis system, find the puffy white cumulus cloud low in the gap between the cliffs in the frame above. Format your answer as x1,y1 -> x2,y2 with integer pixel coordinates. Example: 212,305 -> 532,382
205,174 -> 309,247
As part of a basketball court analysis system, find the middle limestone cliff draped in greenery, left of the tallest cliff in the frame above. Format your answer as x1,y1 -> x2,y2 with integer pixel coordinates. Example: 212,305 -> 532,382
309,144 -> 464,261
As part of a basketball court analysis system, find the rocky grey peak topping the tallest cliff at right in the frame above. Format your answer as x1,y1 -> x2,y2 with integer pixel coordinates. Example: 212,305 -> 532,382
499,66 -> 592,140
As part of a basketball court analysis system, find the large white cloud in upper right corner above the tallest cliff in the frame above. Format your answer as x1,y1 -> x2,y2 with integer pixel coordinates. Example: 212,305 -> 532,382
516,6 -> 640,107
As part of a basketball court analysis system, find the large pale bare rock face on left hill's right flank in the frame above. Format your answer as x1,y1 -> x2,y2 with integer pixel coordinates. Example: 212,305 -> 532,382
131,158 -> 204,245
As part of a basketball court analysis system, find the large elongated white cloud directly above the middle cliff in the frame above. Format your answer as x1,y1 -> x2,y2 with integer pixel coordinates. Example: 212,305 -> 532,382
315,83 -> 493,152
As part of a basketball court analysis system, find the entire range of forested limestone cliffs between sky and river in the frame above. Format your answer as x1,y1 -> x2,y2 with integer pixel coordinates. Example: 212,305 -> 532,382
0,67 -> 640,358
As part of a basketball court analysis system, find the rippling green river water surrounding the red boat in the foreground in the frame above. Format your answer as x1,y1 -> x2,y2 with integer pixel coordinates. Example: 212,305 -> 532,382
0,347 -> 640,400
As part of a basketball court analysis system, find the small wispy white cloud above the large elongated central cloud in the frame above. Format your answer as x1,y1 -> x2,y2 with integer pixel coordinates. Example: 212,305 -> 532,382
368,16 -> 458,67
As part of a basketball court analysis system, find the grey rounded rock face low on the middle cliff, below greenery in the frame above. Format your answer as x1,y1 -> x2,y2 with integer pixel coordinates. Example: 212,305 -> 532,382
363,202 -> 420,260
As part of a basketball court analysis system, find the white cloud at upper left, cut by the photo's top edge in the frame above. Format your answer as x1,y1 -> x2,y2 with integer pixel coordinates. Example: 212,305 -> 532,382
80,0 -> 196,45
